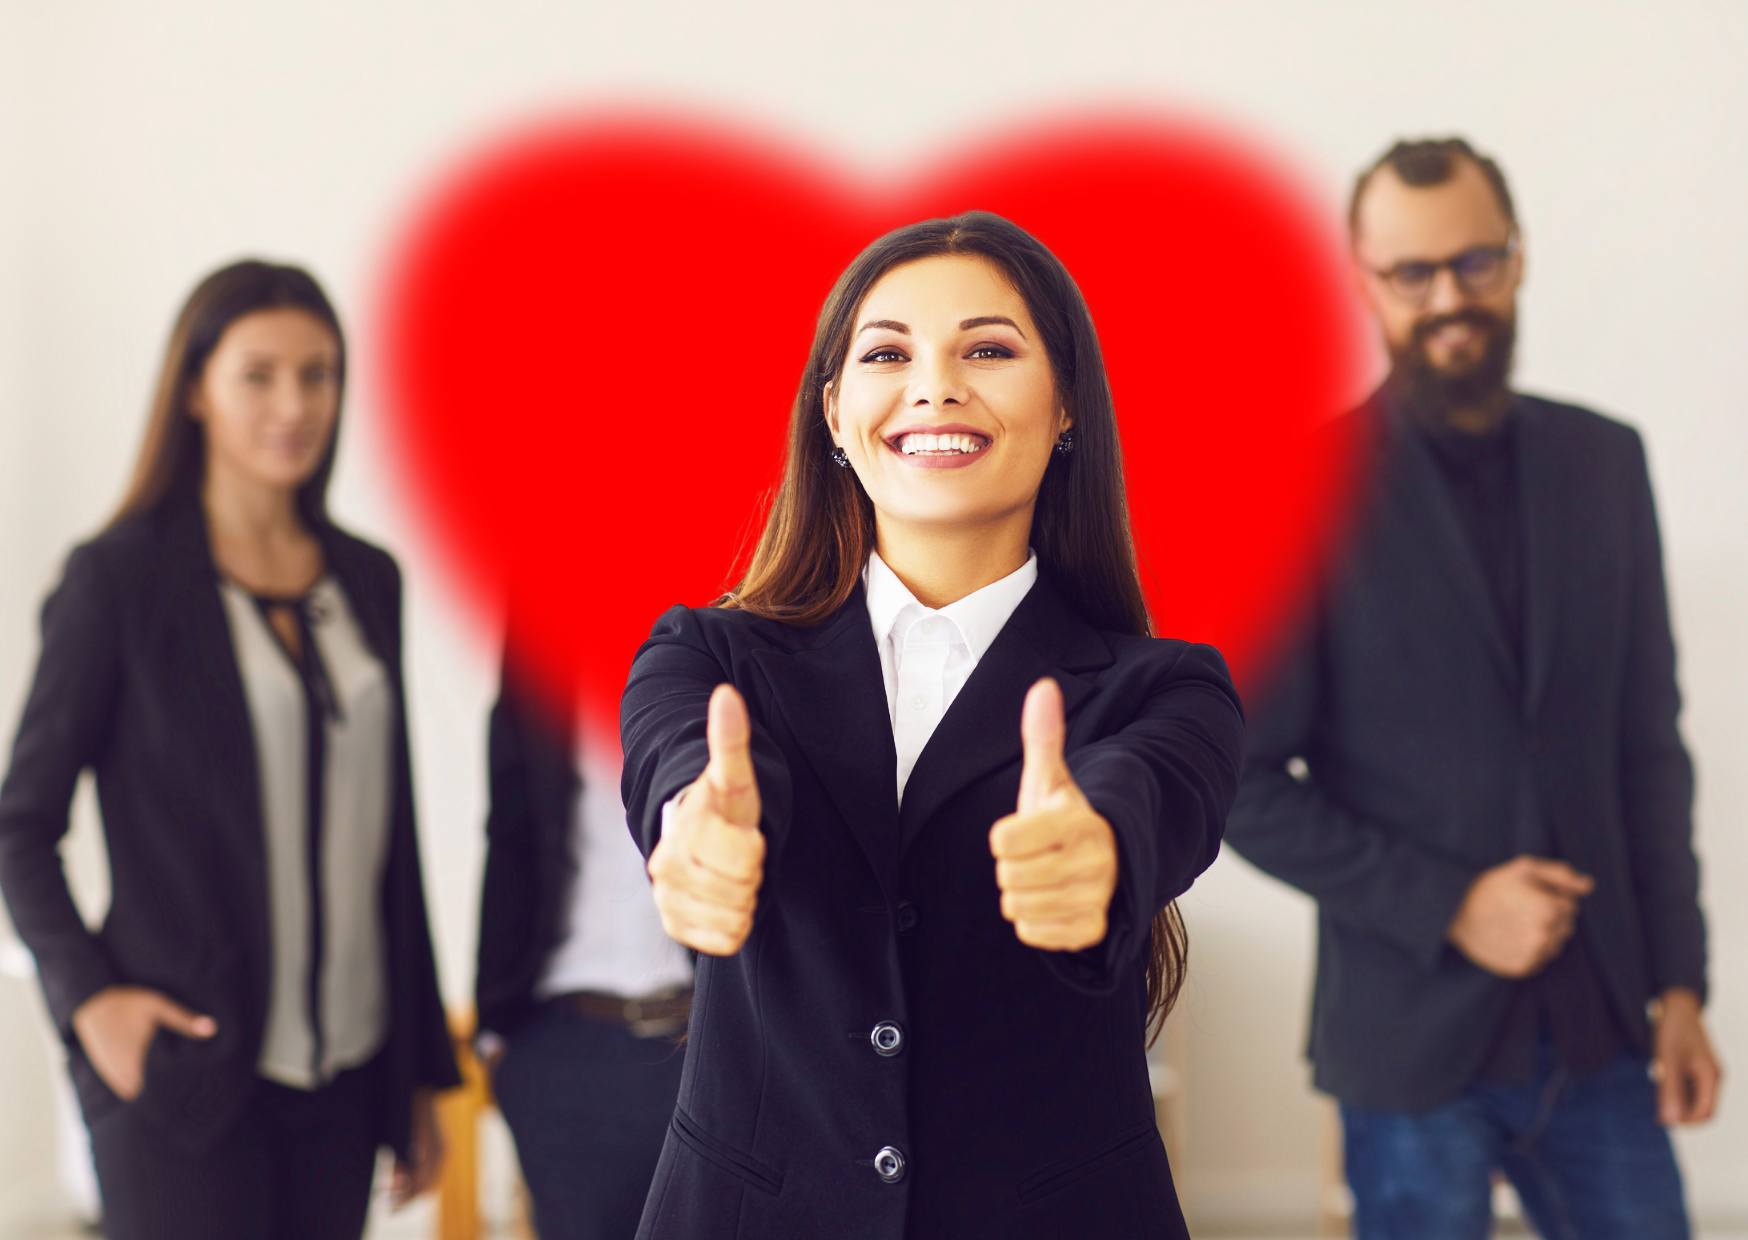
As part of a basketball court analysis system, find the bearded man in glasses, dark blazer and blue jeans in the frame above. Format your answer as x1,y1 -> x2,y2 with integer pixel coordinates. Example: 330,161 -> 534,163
1229,138 -> 1720,1240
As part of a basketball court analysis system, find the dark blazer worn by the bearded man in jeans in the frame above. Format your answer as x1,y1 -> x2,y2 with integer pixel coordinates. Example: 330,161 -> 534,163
1229,397 -> 1706,1111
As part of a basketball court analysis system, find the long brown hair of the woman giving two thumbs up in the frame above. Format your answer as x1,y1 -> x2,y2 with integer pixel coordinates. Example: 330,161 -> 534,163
718,212 -> 1189,1042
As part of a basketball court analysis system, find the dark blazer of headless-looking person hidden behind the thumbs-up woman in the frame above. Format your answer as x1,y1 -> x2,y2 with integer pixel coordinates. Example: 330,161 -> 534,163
474,656 -> 582,1034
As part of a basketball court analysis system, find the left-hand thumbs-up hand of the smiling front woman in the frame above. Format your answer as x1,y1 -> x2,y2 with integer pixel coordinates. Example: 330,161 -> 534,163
649,684 -> 766,957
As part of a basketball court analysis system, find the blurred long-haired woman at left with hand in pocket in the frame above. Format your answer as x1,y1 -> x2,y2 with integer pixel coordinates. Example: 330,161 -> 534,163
0,261 -> 456,1240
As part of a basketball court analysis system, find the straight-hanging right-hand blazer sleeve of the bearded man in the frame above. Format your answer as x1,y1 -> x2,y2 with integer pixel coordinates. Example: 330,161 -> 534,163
1620,434 -> 1706,999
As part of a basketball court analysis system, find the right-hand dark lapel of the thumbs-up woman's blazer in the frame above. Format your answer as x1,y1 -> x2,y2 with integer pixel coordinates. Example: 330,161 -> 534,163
883,574 -> 1112,848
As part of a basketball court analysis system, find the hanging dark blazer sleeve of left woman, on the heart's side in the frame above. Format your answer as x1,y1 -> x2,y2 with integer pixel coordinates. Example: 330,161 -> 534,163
383,554 -> 461,1090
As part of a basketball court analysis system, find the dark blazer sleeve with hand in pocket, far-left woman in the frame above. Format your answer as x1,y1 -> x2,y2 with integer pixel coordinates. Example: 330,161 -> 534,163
0,544 -> 122,1041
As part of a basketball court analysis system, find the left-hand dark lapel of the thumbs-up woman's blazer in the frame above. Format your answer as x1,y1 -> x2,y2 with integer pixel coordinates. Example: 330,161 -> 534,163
753,584 -> 898,895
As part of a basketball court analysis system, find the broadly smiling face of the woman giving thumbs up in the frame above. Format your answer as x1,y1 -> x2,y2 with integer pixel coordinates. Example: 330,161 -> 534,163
825,254 -> 1070,528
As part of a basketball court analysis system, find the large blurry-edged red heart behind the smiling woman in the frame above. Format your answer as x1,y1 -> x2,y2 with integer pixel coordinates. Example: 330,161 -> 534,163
379,115 -> 1362,736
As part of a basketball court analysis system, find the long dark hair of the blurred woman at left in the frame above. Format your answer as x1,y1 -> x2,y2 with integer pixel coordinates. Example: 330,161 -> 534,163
110,259 -> 346,528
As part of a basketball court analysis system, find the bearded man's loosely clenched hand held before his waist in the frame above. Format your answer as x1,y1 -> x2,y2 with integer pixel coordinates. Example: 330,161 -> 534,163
1446,857 -> 1596,978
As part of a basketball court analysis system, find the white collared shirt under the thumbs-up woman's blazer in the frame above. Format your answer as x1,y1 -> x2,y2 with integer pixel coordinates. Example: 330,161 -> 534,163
862,549 -> 1038,803
